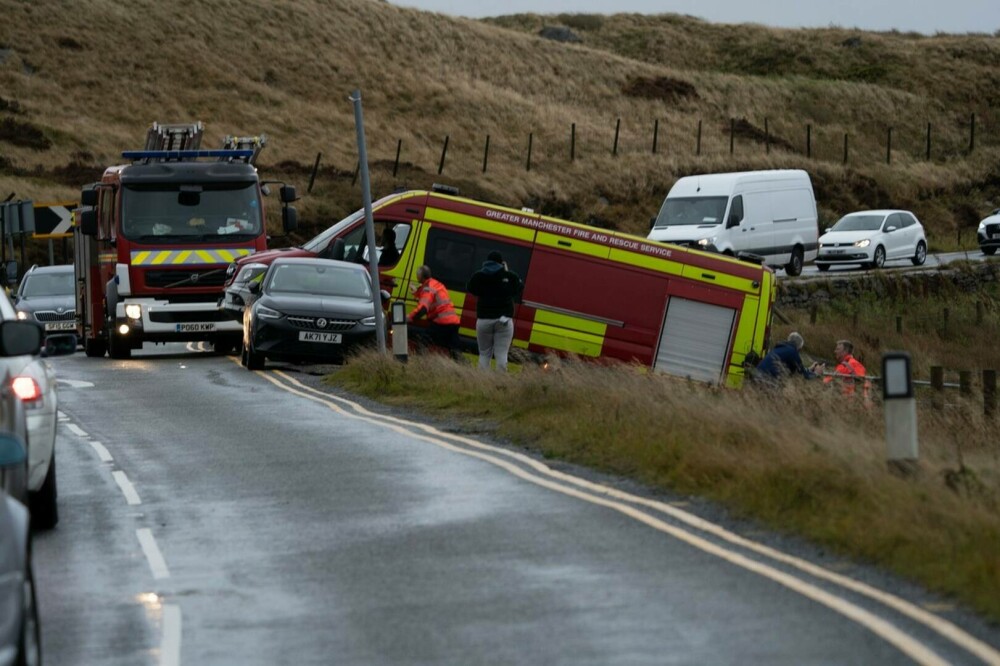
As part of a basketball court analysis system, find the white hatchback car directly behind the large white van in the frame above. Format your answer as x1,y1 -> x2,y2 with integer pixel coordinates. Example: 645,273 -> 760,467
815,210 -> 927,271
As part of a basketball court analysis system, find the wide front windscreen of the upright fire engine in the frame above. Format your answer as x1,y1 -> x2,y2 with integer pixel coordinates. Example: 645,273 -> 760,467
122,183 -> 262,243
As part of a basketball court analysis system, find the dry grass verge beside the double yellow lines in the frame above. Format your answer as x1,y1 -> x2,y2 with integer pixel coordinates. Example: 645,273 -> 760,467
329,344 -> 1000,620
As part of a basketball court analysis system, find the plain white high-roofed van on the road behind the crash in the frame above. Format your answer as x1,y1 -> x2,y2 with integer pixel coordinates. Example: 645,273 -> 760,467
648,169 -> 819,275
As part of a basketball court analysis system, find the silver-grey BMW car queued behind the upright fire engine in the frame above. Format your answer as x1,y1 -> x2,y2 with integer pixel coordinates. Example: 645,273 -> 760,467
14,264 -> 76,335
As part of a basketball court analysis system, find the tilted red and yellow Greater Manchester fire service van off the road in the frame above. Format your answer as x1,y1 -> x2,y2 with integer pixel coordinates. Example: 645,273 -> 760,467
227,188 -> 776,386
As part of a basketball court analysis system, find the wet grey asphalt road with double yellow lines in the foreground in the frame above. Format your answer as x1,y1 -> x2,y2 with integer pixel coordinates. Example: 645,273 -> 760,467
29,345 -> 1000,666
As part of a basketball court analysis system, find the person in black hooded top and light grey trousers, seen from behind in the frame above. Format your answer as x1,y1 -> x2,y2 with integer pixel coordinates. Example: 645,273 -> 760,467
465,252 -> 524,372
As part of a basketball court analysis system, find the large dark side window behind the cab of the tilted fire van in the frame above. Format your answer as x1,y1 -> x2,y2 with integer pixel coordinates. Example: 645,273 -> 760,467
424,227 -> 531,292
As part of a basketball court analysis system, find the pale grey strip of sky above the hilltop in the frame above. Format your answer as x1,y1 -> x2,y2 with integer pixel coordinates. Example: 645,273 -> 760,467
392,0 -> 1000,35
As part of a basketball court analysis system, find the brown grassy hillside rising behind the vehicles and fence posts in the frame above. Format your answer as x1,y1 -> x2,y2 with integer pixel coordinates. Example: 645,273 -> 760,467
0,0 -> 1000,248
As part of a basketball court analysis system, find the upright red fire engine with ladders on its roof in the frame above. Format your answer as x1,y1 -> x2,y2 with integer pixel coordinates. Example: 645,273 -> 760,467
74,122 -> 296,358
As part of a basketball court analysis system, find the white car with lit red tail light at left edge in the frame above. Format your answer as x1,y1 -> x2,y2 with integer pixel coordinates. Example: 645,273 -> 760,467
0,282 -> 76,528
